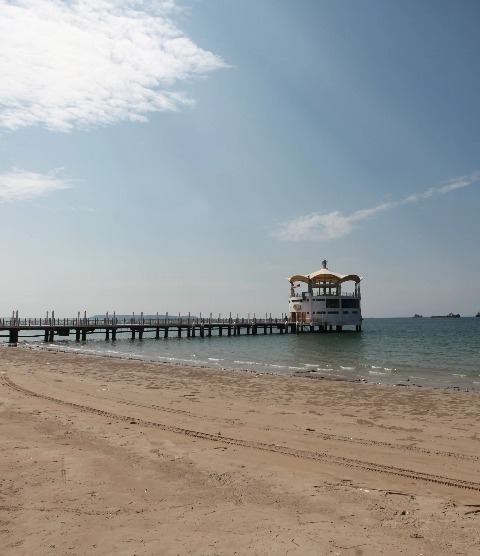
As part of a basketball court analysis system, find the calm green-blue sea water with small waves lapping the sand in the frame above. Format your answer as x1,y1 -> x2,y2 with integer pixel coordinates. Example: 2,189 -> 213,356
13,317 -> 480,392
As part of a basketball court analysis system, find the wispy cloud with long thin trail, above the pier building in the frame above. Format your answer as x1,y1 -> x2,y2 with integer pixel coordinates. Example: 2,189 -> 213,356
271,171 -> 480,241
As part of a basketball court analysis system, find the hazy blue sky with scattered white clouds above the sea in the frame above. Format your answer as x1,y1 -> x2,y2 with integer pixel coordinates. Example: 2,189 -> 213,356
0,0 -> 480,317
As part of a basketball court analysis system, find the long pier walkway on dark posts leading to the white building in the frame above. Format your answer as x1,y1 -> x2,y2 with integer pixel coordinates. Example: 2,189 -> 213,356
0,312 -> 352,344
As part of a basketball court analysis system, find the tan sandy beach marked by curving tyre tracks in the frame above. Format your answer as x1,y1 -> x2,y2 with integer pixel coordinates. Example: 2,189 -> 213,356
0,347 -> 480,556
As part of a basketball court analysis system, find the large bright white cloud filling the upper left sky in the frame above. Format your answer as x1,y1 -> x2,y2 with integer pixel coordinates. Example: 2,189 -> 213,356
0,0 -> 226,131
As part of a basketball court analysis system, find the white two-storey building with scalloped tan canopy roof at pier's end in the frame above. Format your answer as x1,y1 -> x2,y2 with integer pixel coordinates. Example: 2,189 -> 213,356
288,261 -> 362,331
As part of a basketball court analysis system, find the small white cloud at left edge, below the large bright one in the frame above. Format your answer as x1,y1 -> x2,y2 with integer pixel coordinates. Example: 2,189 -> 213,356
0,169 -> 70,201
